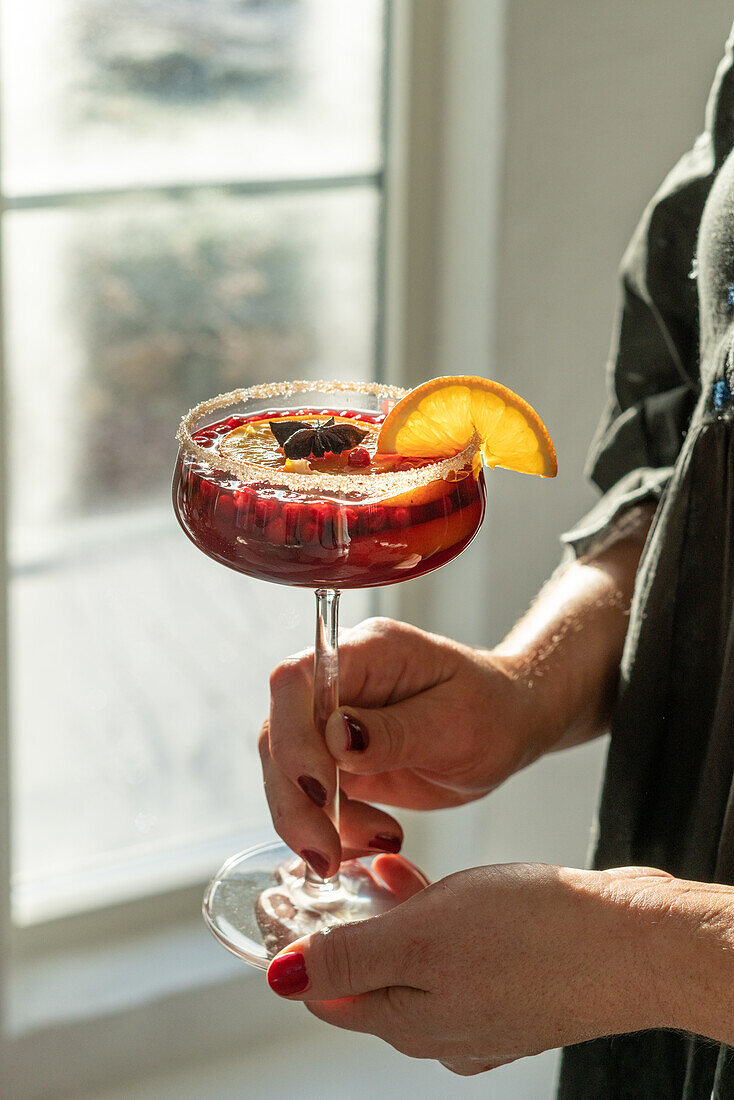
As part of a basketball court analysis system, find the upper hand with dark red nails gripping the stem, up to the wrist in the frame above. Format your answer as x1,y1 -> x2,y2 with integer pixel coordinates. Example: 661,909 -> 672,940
260,618 -> 541,875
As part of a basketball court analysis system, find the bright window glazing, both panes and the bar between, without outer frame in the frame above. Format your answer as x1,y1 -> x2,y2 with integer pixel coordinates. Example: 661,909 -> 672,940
0,0 -> 384,925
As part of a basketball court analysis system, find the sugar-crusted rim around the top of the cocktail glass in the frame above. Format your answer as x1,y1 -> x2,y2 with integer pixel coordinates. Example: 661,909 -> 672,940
176,381 -> 479,496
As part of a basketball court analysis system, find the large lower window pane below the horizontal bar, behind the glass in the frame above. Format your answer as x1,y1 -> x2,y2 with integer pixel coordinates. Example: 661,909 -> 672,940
4,188 -> 379,919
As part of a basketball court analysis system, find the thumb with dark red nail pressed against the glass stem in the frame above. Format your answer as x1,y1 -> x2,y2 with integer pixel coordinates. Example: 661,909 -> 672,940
326,691 -> 443,776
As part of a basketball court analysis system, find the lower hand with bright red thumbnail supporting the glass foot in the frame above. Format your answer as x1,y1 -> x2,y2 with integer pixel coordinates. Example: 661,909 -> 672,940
267,864 -> 676,1075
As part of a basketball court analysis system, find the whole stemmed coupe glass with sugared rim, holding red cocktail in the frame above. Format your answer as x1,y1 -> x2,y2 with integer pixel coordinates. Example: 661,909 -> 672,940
173,382 -> 484,969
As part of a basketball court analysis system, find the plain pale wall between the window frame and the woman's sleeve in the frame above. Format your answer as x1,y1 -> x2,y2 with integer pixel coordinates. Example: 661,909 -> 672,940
484,0 -> 734,629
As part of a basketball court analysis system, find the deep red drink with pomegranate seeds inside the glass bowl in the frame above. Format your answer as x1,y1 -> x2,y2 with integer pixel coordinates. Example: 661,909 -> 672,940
174,408 -> 484,589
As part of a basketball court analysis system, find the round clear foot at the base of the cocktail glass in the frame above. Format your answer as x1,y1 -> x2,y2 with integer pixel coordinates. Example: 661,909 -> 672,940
202,840 -> 397,970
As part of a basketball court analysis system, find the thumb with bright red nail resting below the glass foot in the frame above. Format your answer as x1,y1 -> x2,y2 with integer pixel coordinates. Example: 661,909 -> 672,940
267,913 -> 403,1001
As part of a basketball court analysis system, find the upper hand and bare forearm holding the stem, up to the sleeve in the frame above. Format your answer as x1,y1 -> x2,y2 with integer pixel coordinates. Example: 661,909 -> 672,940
260,508 -> 653,875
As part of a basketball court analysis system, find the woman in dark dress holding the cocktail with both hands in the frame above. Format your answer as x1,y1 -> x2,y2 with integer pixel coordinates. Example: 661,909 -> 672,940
262,25 -> 734,1100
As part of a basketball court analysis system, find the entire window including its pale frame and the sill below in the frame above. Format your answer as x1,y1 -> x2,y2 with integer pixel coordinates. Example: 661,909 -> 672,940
0,0 -> 515,1100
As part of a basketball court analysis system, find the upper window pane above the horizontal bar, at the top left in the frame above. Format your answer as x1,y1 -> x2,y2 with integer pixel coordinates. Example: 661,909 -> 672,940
0,0 -> 383,195
